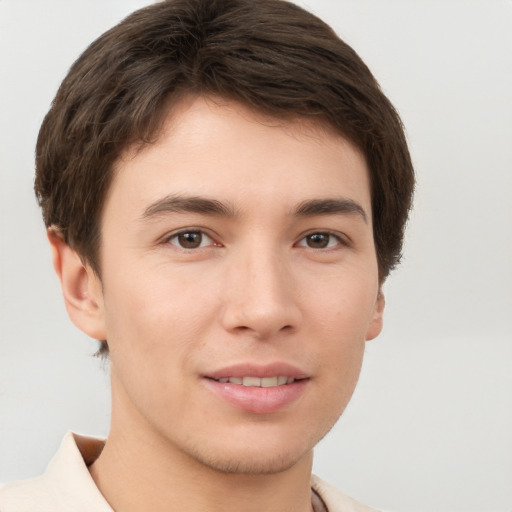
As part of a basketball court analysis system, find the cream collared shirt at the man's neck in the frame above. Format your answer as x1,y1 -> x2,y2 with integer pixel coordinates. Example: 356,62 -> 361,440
0,433 -> 376,512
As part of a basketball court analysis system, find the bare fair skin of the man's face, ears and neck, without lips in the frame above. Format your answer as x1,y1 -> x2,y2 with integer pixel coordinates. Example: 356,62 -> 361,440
49,98 -> 384,512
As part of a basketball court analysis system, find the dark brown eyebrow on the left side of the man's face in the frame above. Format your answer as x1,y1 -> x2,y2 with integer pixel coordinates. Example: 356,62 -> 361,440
142,194 -> 236,220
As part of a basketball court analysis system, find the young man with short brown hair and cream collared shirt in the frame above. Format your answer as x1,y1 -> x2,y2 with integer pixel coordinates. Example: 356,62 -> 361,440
0,0 -> 414,512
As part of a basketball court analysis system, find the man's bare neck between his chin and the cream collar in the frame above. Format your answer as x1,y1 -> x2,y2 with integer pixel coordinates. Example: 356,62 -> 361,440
89,386 -> 312,512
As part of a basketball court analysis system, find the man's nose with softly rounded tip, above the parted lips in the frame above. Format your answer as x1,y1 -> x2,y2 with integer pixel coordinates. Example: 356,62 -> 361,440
222,247 -> 301,339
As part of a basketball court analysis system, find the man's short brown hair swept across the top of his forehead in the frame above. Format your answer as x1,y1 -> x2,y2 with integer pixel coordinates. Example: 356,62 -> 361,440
35,0 -> 414,340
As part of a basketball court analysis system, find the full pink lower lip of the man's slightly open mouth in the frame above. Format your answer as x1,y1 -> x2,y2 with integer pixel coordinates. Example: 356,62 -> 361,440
204,379 -> 309,414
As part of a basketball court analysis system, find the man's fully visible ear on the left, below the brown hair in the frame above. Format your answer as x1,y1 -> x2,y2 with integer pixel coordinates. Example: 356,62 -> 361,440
46,227 -> 106,340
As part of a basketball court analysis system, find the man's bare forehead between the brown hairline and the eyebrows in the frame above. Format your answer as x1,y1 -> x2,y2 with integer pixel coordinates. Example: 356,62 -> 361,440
105,97 -> 370,218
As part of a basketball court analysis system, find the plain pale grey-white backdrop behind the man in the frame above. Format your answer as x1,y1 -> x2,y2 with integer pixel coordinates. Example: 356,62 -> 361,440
0,0 -> 512,512
